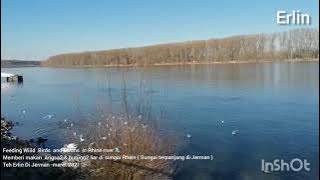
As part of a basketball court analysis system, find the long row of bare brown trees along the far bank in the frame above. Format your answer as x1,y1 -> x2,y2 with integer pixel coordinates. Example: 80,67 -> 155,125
39,28 -> 319,67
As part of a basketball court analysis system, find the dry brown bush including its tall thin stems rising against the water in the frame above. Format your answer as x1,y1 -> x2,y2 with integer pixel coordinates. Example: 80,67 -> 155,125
66,77 -> 183,180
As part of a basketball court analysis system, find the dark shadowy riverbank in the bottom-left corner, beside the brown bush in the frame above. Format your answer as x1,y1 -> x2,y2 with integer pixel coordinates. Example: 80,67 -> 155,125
1,116 -> 82,180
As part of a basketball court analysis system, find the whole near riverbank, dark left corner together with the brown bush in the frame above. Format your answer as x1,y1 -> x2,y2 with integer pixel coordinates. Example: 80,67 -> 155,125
1,115 -> 176,179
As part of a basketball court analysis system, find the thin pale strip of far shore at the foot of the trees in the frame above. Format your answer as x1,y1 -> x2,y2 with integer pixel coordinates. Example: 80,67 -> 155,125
43,59 -> 319,68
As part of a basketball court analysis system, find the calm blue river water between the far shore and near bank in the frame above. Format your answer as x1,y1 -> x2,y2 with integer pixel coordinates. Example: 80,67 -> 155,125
1,63 -> 319,180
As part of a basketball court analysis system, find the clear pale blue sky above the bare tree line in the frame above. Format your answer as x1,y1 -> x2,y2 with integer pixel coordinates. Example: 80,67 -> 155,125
1,0 -> 319,60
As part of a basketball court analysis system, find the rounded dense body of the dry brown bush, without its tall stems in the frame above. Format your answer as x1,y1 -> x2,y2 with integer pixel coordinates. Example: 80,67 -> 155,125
70,113 -> 177,179
